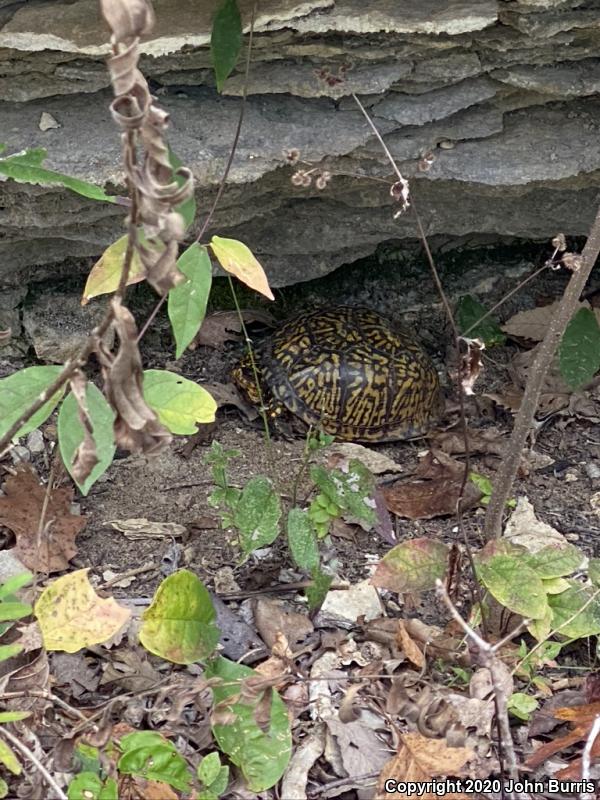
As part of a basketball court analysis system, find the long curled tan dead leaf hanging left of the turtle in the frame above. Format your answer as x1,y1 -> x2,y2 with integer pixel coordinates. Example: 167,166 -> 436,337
96,298 -> 171,455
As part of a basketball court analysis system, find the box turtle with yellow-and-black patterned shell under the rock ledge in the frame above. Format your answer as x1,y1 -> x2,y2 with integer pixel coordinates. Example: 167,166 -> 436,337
233,306 -> 442,442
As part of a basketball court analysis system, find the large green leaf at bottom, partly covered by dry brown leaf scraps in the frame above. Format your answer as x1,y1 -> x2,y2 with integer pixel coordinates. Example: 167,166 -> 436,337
205,657 -> 292,792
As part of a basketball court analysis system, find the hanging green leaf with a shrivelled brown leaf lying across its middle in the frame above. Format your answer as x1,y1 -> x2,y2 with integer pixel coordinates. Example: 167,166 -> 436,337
58,383 -> 116,497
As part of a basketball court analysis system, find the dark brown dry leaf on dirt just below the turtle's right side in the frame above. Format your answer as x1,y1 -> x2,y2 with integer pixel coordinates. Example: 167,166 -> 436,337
382,450 -> 481,519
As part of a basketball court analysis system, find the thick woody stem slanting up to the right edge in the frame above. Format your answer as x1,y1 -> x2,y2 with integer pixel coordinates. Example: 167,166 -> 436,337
484,203 -> 600,540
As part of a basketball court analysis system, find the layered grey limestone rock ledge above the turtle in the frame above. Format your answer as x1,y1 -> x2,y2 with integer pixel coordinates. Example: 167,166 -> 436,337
0,0 -> 600,290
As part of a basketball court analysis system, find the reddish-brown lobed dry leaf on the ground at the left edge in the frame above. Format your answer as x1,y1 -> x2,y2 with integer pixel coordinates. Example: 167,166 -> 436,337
0,469 -> 87,572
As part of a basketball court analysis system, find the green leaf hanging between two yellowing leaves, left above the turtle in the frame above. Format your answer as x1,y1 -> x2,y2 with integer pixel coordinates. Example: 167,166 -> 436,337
168,242 -> 212,358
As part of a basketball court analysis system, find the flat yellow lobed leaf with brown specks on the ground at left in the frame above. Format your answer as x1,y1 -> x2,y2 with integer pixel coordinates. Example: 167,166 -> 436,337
34,569 -> 131,653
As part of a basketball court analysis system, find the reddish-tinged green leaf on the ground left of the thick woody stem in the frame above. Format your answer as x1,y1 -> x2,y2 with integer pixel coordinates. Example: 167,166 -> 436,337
372,538 -> 448,593
